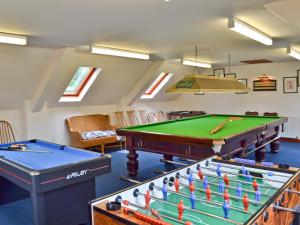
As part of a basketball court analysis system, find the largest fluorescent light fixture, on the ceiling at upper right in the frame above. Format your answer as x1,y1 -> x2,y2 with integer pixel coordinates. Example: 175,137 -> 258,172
228,17 -> 273,45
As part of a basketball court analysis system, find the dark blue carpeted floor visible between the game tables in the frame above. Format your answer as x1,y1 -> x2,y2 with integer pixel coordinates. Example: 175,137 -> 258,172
0,143 -> 300,225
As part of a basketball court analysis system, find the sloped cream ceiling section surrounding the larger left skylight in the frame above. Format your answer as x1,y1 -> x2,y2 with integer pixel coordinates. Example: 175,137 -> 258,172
47,52 -> 151,107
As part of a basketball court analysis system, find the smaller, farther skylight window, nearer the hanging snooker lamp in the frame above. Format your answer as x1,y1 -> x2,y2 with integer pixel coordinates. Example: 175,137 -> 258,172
141,73 -> 173,99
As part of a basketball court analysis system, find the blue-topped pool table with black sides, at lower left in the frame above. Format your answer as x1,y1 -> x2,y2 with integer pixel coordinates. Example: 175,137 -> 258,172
0,140 -> 111,225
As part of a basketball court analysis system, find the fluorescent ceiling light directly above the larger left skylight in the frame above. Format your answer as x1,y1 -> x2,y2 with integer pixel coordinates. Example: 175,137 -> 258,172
91,46 -> 150,60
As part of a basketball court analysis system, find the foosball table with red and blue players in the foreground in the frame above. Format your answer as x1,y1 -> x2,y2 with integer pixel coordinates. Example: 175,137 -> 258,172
90,156 -> 300,225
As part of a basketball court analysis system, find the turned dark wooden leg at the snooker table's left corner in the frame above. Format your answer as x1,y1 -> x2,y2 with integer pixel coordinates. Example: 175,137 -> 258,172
126,137 -> 139,176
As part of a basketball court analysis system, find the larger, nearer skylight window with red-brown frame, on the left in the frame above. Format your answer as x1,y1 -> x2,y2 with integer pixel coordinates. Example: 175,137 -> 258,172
59,66 -> 101,102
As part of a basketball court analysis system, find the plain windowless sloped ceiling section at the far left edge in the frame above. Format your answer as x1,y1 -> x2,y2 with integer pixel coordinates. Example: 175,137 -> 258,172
0,45 -> 53,110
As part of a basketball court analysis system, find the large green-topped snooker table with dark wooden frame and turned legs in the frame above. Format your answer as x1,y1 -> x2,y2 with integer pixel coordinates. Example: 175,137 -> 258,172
117,114 -> 287,176
